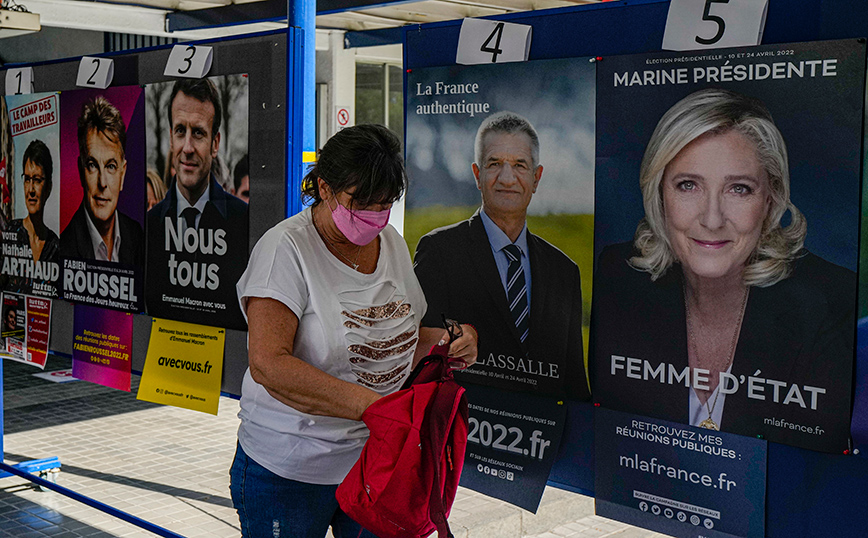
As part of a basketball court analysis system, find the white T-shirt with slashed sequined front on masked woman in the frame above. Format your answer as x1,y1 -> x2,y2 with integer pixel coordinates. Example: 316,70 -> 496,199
237,209 -> 427,484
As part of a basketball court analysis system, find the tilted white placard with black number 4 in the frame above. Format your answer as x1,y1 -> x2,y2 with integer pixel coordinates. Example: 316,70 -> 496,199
455,19 -> 533,65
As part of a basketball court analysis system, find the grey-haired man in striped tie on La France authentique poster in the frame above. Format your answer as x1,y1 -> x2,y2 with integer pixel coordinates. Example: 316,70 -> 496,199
415,112 -> 590,399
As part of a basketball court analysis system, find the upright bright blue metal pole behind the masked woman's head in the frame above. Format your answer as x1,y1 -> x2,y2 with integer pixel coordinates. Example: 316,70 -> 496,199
286,0 -> 316,216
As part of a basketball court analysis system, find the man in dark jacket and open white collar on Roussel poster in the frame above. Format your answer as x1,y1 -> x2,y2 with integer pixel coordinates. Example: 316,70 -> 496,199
60,96 -> 144,266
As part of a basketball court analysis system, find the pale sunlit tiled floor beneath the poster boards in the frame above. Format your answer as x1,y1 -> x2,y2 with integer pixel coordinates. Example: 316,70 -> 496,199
0,356 -> 662,538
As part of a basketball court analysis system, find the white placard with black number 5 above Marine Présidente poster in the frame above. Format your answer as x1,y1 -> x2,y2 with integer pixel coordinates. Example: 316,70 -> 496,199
663,0 -> 768,50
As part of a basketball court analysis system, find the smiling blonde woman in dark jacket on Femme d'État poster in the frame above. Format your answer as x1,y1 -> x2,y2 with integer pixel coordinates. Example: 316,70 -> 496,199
591,89 -> 856,450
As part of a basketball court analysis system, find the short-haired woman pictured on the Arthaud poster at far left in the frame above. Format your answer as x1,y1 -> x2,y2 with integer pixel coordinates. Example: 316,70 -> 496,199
7,140 -> 60,262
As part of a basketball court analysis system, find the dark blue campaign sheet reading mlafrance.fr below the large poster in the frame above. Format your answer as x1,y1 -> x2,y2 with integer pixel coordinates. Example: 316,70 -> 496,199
594,408 -> 768,538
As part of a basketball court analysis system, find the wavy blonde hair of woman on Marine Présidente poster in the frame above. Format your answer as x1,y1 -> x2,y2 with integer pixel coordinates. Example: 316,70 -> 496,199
630,88 -> 807,287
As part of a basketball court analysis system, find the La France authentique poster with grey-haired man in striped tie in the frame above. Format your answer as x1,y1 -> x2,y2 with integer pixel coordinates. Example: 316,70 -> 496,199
404,58 -> 595,399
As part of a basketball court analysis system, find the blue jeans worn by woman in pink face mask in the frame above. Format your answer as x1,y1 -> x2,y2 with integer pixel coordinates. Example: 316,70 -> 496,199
229,445 -> 377,538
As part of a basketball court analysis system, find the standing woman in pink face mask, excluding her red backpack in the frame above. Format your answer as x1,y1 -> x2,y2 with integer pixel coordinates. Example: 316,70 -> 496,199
231,125 -> 476,538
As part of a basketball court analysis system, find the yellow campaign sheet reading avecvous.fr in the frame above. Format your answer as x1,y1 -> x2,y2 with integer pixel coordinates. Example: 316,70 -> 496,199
136,319 -> 226,415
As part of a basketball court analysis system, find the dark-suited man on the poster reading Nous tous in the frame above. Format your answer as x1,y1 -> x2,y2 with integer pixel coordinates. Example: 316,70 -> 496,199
146,79 -> 248,329
